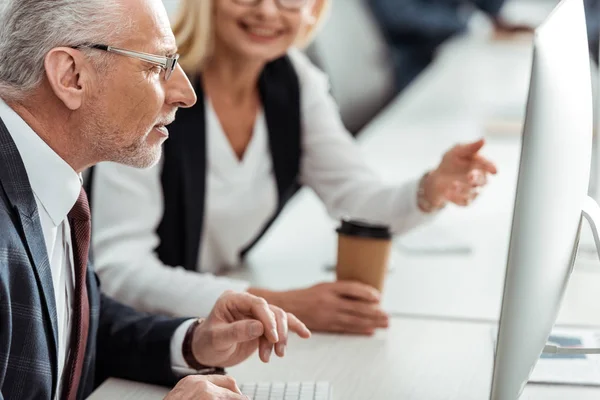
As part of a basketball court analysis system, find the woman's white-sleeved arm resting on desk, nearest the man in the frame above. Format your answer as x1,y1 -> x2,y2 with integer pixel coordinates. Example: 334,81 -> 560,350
92,159 -> 249,316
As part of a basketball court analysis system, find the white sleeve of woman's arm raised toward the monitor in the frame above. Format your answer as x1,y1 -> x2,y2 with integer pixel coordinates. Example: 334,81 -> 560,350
291,52 -> 431,233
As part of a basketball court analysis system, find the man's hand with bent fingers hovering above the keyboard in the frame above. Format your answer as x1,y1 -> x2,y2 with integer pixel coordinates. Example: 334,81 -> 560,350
192,292 -> 310,367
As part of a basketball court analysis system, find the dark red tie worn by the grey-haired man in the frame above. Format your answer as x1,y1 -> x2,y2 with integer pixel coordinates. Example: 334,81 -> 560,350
63,189 -> 91,400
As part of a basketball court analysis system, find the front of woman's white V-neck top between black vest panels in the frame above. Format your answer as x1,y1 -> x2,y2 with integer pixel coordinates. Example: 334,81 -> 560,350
198,99 -> 278,273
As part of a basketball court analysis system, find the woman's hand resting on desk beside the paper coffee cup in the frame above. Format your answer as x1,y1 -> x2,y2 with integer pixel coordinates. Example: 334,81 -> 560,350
250,282 -> 389,335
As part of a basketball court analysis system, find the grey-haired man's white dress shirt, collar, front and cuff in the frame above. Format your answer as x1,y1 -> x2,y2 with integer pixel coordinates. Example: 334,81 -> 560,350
0,99 -> 193,398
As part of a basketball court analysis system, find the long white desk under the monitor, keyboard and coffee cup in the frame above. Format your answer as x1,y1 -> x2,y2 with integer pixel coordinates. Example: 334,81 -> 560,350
92,3 -> 600,400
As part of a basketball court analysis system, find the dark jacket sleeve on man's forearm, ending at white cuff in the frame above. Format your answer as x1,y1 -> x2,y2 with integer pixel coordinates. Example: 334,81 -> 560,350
96,295 -> 186,386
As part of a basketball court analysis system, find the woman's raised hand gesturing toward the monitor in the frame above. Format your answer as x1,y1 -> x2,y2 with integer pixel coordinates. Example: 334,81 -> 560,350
425,139 -> 497,207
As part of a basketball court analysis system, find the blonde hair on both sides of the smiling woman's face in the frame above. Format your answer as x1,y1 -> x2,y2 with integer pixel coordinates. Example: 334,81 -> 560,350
173,0 -> 330,77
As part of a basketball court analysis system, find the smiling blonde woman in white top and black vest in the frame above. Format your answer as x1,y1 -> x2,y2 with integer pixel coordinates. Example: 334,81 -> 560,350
86,0 -> 495,335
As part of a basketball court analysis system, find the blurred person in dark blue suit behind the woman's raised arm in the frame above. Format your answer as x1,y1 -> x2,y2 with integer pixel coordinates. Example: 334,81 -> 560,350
366,0 -> 536,93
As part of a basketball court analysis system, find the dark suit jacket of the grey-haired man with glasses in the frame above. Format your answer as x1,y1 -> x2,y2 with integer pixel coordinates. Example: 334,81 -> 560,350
0,114 -> 188,400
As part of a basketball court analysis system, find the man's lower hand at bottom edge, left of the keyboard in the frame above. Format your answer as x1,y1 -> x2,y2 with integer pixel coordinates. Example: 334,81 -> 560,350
164,375 -> 248,400
